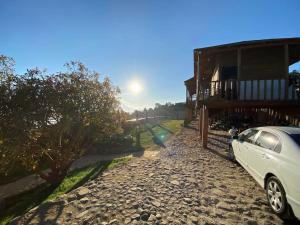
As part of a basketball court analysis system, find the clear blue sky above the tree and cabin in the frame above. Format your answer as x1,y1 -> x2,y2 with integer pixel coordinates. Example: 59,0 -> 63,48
0,0 -> 300,110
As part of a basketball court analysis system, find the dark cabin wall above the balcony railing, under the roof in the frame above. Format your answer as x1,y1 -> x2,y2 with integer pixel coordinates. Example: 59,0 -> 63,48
208,45 -> 287,81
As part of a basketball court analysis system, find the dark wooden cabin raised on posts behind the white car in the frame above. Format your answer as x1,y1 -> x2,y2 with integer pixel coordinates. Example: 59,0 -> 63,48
185,38 -> 300,147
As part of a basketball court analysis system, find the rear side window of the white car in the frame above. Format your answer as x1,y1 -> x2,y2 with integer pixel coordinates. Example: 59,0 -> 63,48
255,131 -> 281,152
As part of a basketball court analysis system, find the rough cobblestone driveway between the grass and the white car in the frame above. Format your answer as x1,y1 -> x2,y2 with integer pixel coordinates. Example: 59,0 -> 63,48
14,123 -> 294,225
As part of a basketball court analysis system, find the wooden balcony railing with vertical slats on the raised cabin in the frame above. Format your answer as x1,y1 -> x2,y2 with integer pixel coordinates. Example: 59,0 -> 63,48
199,79 -> 300,101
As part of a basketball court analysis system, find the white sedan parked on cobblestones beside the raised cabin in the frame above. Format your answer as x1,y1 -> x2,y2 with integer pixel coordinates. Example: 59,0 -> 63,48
231,127 -> 300,220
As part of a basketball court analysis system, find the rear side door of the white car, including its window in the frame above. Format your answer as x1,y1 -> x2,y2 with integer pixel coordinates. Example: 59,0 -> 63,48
247,131 -> 281,184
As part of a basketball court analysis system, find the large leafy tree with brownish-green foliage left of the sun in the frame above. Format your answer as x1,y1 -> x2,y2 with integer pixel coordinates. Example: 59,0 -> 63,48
0,56 -> 119,183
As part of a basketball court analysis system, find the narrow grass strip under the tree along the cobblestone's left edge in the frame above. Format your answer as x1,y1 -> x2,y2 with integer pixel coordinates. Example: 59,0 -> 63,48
0,157 -> 131,225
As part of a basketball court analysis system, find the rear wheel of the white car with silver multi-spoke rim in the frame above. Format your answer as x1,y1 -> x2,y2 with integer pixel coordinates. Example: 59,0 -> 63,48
266,176 -> 290,219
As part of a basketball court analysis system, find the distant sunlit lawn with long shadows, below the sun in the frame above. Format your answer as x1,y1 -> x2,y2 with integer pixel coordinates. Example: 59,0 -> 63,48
131,120 -> 183,150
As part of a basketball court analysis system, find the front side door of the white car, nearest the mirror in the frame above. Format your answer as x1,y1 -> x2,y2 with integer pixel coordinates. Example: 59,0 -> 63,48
237,129 -> 258,166
